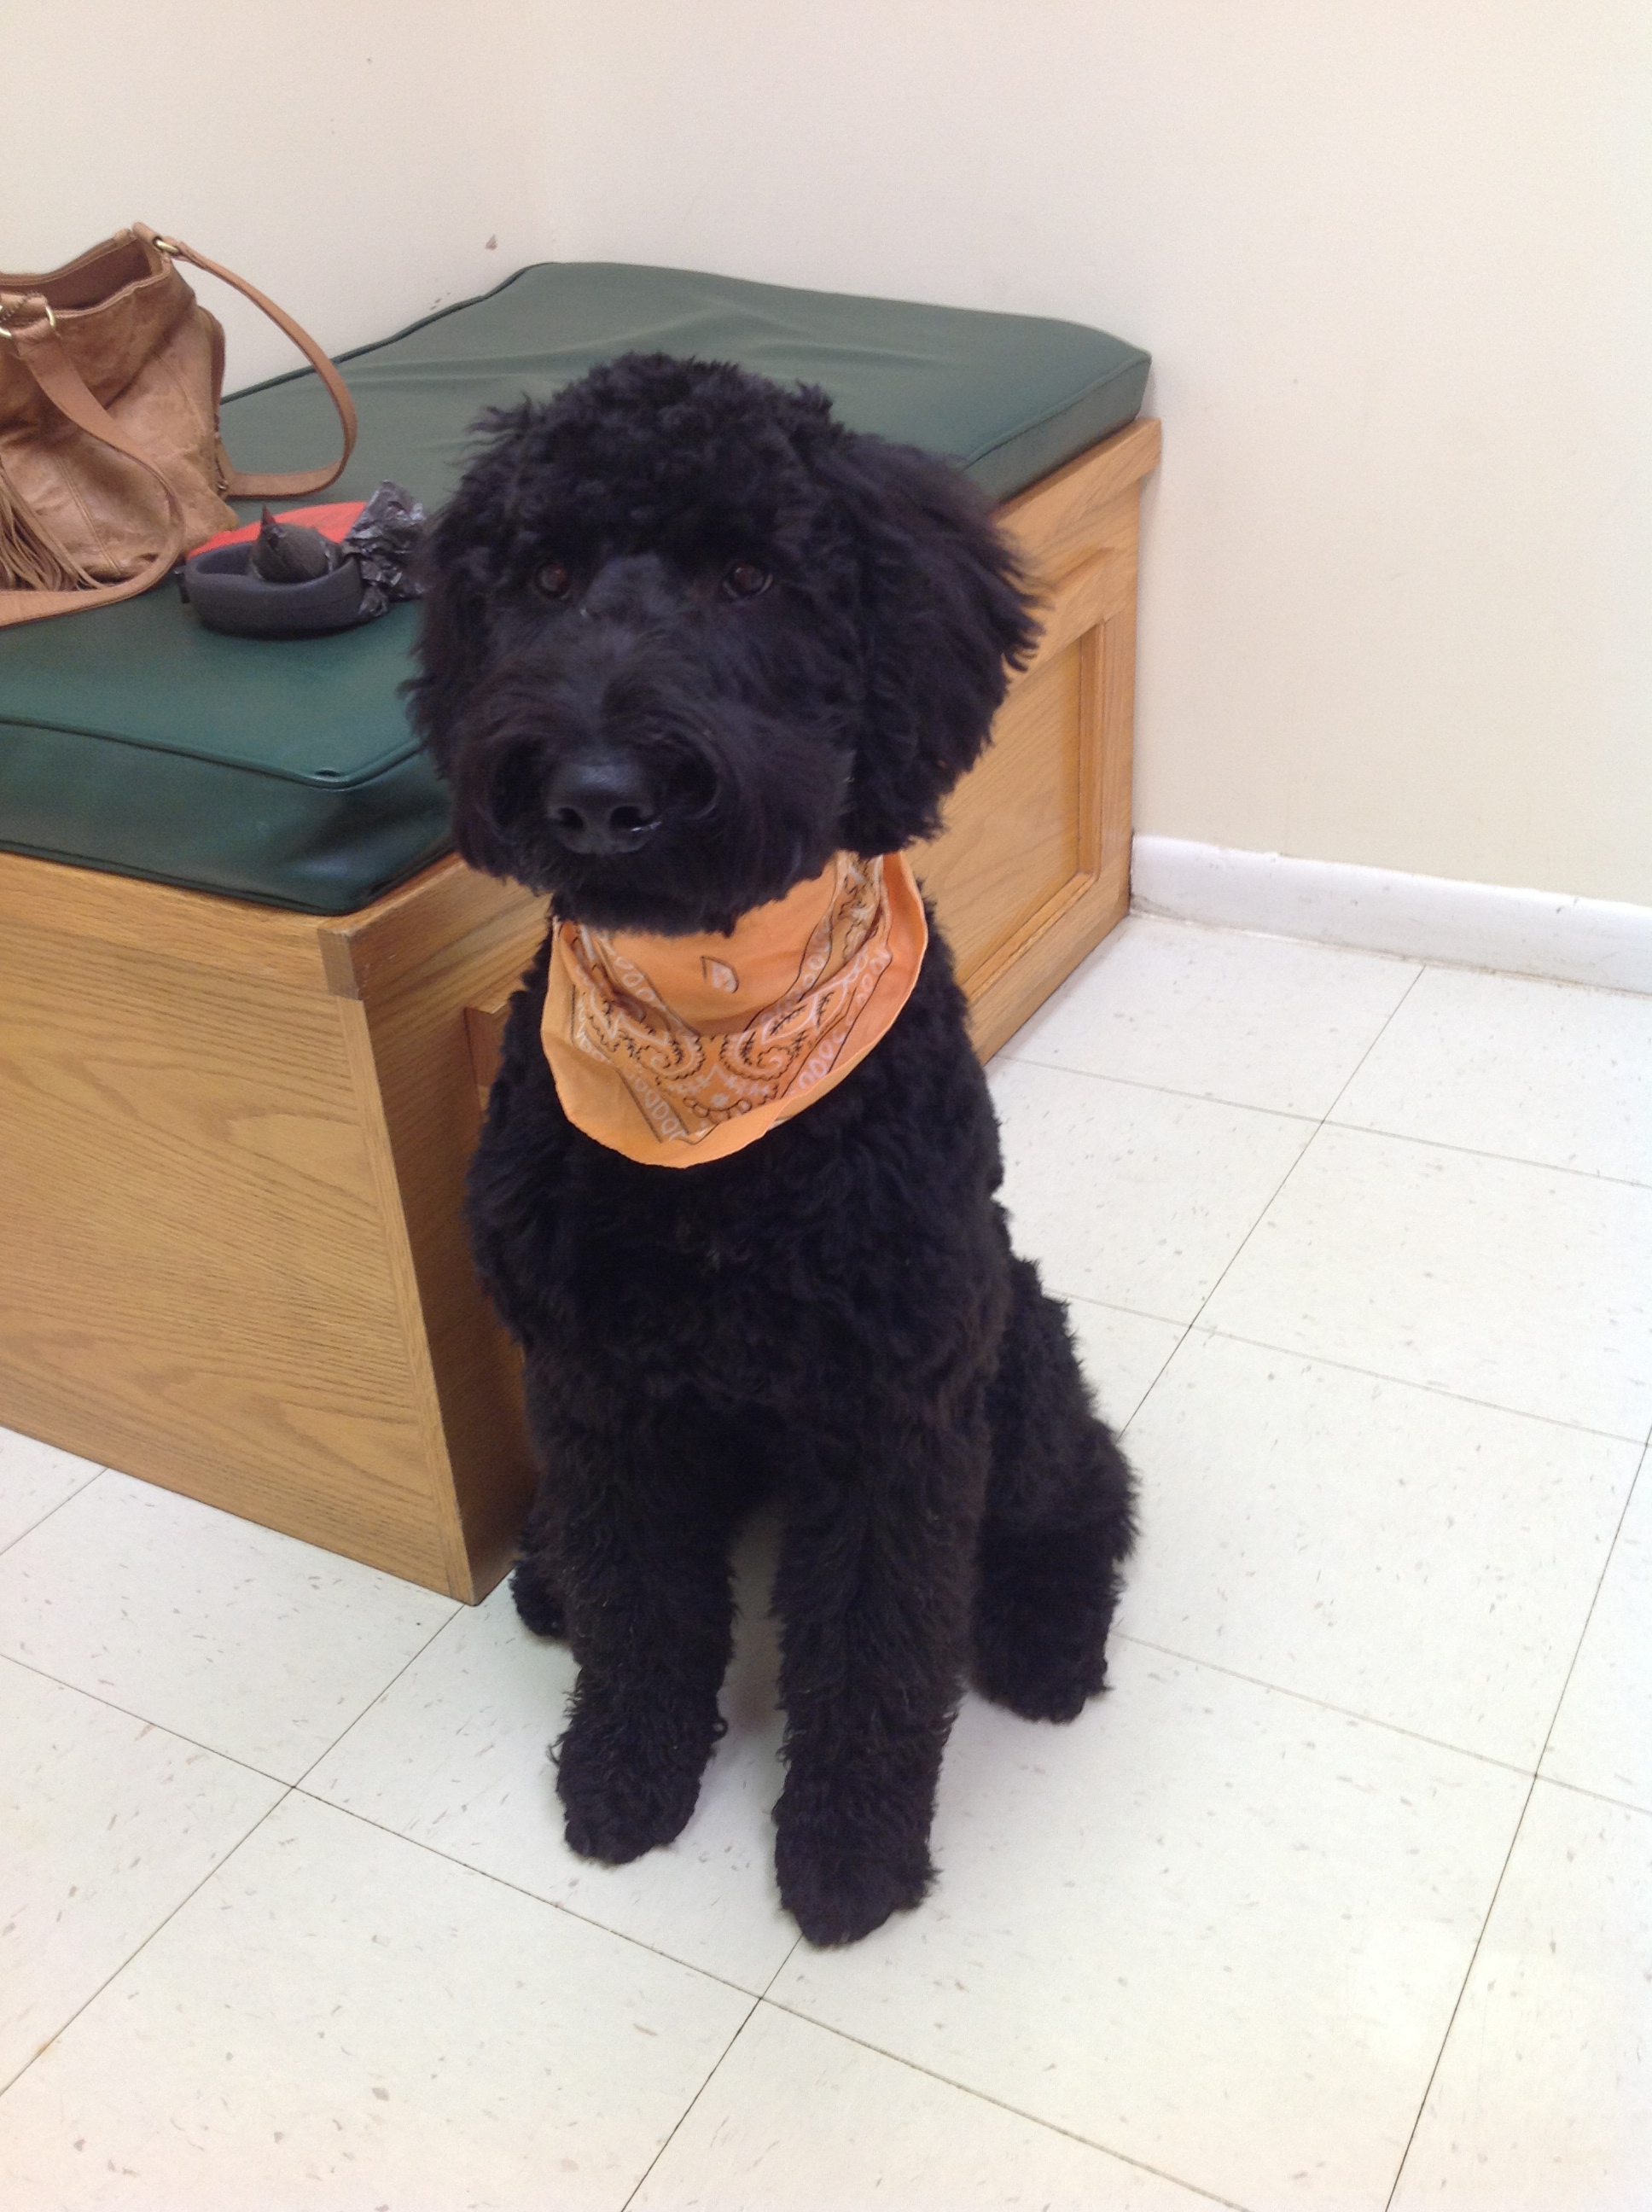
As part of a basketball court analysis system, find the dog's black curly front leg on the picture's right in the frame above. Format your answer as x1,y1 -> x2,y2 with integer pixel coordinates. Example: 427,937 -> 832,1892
774,1407 -> 988,1944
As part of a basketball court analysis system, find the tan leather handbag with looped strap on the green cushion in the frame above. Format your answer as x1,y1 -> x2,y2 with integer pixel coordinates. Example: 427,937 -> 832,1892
0,224 -> 356,628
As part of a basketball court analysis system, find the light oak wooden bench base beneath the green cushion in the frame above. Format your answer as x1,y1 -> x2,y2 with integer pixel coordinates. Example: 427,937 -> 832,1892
0,420 -> 1159,1602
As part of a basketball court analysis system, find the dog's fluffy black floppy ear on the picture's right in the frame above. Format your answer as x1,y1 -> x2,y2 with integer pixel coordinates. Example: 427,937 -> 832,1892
810,436 -> 1038,854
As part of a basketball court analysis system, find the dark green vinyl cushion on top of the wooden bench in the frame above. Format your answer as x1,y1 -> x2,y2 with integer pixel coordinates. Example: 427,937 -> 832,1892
0,261 -> 1148,913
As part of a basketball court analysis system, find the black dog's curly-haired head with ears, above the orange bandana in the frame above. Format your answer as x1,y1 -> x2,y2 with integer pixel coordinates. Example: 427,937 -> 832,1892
409,354 -> 1035,934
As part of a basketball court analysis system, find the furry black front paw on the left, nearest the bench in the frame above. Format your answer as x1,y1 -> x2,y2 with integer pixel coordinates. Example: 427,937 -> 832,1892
556,1705 -> 717,1867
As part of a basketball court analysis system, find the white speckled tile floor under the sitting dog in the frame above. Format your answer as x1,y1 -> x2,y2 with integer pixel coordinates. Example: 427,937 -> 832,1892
0,918 -> 1652,2212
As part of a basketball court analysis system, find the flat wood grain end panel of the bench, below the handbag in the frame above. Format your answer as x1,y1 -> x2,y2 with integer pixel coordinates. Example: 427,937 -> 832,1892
0,924 -> 447,1588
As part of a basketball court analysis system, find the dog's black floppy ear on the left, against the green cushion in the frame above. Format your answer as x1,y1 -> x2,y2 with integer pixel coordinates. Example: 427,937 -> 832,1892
403,403 -> 535,781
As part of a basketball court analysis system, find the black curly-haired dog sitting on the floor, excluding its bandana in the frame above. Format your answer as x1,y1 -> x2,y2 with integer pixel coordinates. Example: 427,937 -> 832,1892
411,354 -> 1132,1944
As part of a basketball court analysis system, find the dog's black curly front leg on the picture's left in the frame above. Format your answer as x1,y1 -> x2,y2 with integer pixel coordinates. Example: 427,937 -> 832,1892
550,1424 -> 734,1865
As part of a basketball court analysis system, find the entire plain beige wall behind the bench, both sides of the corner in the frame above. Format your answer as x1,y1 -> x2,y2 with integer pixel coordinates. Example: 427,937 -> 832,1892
13,0 -> 1652,903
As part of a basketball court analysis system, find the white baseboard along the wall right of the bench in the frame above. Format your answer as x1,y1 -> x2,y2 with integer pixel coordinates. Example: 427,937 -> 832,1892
1130,836 -> 1652,993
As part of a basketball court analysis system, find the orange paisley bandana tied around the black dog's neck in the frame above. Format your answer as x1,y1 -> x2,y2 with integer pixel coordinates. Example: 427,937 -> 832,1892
539,852 -> 929,1168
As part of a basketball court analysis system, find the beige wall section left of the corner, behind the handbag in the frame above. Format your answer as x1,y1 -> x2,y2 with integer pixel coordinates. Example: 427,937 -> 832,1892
0,0 -> 553,389
